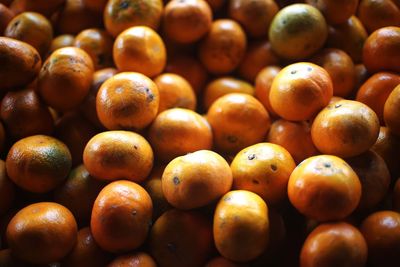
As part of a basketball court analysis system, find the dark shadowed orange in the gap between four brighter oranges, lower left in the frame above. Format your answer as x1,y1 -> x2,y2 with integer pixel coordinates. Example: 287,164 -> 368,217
54,165 -> 105,225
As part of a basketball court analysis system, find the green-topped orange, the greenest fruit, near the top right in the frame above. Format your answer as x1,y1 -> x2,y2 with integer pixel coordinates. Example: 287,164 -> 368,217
268,4 -> 328,60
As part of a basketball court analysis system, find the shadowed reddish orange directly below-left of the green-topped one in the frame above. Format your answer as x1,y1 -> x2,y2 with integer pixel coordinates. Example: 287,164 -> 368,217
237,41 -> 279,82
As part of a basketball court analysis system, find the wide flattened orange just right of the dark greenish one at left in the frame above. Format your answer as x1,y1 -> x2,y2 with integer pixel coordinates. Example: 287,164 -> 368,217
83,131 -> 153,182
